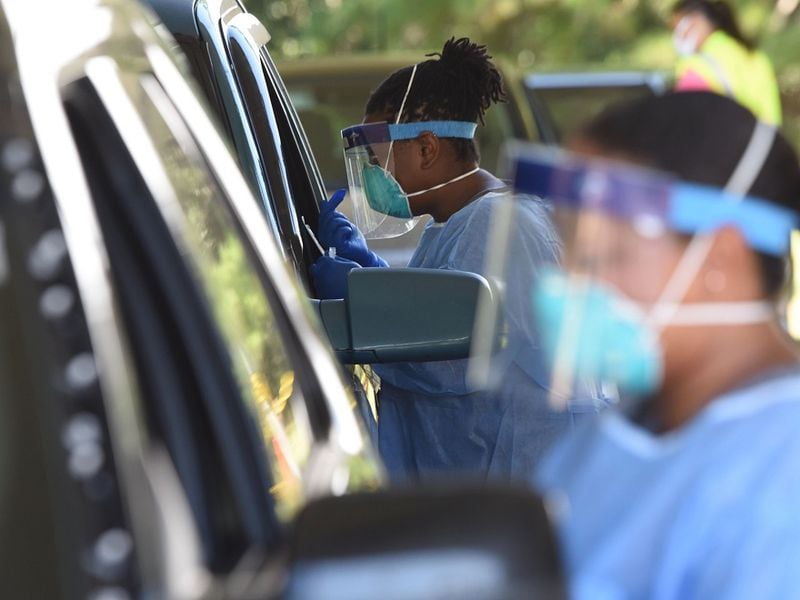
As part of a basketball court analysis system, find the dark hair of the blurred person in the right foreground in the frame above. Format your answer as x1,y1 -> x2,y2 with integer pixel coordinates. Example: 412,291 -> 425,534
577,92 -> 800,297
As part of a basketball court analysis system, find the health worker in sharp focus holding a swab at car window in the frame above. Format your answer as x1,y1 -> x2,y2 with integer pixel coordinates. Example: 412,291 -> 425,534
312,38 -> 593,480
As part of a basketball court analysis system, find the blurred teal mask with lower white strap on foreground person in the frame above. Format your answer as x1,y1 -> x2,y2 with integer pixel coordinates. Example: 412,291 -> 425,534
533,269 -> 775,397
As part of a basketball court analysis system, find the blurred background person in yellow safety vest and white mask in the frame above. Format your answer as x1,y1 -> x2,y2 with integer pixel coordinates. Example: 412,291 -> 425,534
672,0 -> 781,125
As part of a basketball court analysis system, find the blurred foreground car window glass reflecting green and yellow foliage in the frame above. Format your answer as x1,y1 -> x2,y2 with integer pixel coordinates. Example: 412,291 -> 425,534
136,74 -> 313,518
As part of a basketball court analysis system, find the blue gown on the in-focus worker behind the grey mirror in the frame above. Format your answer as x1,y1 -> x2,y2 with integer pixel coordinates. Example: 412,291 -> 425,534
375,193 -> 594,481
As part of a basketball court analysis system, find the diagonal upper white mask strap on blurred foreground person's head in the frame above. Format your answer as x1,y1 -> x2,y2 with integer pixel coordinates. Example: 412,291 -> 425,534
648,121 -> 777,330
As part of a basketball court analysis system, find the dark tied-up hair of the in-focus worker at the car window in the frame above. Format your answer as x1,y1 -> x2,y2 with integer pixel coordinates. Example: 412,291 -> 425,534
365,38 -> 506,162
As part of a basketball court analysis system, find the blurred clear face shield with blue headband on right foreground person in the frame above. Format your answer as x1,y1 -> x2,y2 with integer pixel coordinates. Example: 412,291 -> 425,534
471,125 -> 797,408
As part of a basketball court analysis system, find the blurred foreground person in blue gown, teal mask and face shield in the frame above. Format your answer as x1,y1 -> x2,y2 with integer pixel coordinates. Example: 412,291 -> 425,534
517,92 -> 800,600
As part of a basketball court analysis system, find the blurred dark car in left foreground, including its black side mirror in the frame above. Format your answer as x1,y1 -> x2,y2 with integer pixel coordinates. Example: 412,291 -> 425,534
0,0 -> 563,600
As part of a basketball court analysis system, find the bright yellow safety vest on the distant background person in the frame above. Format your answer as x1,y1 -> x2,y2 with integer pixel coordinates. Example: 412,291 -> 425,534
676,31 -> 782,125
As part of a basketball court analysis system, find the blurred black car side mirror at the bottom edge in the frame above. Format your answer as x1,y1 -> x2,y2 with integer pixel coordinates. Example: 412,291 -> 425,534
283,486 -> 567,600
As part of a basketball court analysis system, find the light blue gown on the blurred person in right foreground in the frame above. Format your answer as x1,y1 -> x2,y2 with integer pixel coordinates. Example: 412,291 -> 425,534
537,370 -> 800,600
